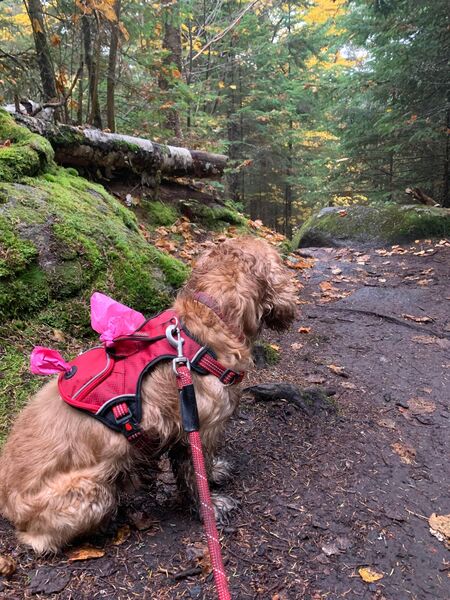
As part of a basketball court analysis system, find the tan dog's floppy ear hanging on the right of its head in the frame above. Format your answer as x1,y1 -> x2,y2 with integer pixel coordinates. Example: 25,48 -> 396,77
261,247 -> 297,330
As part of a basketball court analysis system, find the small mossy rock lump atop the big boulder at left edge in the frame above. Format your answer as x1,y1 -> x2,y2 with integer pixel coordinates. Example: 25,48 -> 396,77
0,109 -> 54,182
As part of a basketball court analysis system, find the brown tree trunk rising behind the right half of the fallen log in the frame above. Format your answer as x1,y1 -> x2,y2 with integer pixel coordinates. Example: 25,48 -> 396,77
158,0 -> 182,139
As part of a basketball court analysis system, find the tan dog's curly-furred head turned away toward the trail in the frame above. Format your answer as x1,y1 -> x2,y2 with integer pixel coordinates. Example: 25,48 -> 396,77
187,237 -> 296,338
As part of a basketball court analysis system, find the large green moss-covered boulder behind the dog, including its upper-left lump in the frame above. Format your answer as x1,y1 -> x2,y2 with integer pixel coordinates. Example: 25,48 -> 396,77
0,108 -> 186,323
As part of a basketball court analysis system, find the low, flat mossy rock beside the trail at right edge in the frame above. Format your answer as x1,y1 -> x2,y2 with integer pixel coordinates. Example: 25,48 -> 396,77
292,204 -> 450,249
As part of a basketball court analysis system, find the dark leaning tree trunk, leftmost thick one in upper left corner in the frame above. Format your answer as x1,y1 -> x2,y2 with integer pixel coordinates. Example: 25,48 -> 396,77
25,0 -> 58,102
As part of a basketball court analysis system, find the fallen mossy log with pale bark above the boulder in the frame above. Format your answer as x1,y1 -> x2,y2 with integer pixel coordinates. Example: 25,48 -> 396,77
12,113 -> 228,180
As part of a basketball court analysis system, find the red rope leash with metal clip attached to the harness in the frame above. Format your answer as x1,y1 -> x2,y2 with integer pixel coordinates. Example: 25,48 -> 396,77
166,318 -> 231,600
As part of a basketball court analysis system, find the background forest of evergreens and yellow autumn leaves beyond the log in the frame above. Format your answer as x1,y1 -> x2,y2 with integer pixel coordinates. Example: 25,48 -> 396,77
0,0 -> 450,235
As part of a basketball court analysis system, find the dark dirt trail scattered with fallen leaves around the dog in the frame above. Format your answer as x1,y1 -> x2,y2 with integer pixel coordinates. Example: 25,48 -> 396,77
0,242 -> 450,600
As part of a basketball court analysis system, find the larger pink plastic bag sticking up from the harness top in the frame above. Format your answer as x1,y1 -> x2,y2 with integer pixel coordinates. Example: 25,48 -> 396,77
91,292 -> 145,346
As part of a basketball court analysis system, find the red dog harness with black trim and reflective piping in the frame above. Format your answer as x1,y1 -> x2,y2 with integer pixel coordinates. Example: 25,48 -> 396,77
58,309 -> 244,442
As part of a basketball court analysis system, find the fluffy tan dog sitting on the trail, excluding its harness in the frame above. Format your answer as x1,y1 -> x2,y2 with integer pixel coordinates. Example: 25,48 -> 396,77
0,237 -> 295,553
